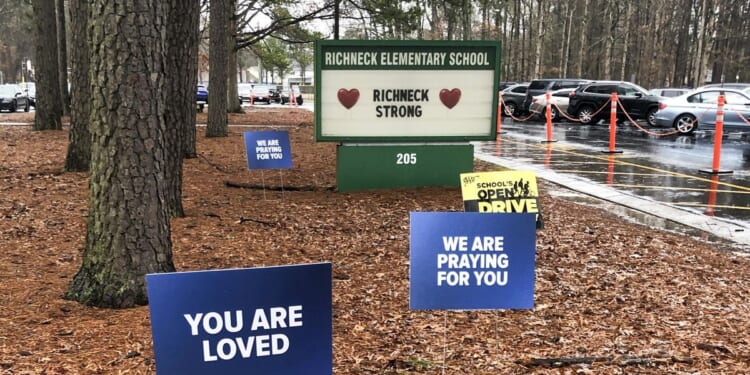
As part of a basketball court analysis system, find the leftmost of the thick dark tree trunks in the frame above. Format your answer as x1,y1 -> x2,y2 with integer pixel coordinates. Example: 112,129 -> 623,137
31,0 -> 62,130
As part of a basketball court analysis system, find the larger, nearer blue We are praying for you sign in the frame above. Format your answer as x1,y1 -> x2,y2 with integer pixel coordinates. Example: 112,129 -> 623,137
409,212 -> 536,310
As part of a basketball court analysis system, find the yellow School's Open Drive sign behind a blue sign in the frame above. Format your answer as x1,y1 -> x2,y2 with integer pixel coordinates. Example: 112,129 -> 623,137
461,171 -> 543,228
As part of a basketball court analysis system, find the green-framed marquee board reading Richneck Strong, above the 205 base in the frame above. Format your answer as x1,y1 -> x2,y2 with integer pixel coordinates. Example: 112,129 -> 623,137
315,40 -> 501,142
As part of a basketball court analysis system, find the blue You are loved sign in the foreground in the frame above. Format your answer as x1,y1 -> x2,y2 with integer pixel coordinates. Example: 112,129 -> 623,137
146,263 -> 333,375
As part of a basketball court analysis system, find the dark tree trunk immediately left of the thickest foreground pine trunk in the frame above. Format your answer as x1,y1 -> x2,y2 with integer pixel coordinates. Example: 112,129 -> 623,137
65,0 -> 91,172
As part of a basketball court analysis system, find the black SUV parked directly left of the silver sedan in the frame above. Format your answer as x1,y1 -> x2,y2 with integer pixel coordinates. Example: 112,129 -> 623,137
568,81 -> 660,126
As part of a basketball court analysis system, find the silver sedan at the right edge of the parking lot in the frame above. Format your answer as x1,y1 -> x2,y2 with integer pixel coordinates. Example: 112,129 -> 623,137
655,86 -> 750,134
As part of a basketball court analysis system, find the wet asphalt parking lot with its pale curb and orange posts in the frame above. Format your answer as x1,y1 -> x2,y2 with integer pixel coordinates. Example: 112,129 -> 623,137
474,119 -> 750,250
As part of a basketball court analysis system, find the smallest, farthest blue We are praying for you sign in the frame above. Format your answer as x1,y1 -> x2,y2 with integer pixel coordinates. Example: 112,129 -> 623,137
244,131 -> 292,169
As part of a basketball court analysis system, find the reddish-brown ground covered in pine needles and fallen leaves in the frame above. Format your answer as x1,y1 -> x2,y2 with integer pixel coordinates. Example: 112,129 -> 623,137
0,109 -> 750,374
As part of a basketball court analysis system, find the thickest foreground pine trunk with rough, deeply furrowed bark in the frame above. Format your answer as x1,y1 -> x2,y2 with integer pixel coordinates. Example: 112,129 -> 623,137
66,0 -> 175,308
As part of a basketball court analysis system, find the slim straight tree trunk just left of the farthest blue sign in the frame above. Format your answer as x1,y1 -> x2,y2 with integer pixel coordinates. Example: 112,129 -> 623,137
206,0 -> 228,137
